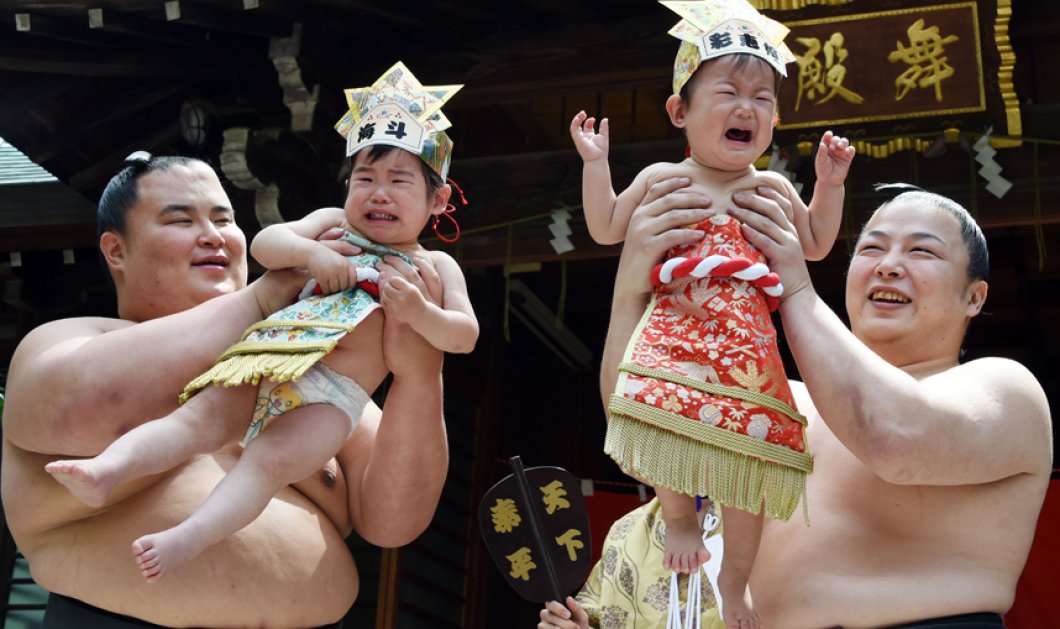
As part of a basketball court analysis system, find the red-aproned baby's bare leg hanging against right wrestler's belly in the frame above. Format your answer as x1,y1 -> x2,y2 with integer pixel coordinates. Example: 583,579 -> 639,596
718,507 -> 764,629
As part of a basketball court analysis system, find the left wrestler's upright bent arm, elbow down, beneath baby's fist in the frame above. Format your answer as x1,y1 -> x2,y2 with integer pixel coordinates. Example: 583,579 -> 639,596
336,253 -> 449,547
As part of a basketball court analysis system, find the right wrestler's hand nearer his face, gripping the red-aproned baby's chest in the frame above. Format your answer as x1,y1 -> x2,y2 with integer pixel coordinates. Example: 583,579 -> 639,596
729,186 -> 813,301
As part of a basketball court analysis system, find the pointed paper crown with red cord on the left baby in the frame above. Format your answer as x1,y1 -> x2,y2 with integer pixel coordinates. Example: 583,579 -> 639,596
335,62 -> 463,181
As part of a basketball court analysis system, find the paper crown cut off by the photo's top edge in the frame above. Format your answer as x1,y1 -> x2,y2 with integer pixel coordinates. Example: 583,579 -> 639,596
659,0 -> 795,94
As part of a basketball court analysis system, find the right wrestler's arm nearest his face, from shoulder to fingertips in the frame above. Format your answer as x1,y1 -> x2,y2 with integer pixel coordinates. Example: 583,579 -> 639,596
735,189 -> 1052,485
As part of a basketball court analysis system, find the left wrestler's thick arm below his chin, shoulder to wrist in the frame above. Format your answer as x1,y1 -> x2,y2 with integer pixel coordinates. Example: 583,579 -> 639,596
3,274 -> 304,456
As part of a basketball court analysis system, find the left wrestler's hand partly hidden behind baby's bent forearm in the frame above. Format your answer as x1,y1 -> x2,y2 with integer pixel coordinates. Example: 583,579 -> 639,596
377,252 -> 442,378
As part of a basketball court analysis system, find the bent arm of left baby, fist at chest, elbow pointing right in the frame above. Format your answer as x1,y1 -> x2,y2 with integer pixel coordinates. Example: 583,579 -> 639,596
379,251 -> 478,354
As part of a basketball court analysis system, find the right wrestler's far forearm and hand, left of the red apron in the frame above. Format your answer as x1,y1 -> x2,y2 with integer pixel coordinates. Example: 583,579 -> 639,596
600,178 -> 710,407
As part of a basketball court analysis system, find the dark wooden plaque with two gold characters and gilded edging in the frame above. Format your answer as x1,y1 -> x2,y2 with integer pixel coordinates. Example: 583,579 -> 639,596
772,0 -> 1021,148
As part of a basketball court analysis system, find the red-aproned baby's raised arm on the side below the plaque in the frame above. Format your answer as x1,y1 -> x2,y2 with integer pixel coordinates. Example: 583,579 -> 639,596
789,132 -> 854,260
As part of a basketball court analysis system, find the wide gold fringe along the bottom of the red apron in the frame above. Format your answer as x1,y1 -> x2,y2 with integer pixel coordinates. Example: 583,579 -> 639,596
604,396 -> 813,524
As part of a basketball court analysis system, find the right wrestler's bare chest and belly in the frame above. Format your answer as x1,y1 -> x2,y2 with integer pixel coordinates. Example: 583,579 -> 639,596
750,432 -> 1034,629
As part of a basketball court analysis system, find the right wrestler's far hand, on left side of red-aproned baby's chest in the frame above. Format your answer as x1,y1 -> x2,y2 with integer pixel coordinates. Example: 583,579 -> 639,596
615,177 -> 713,303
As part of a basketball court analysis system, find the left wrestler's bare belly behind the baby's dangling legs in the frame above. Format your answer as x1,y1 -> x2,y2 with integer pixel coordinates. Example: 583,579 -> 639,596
20,445 -> 359,627
